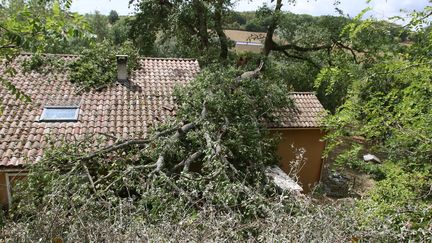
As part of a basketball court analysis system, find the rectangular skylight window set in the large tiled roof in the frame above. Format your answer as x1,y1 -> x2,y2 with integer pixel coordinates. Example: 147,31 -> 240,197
39,106 -> 79,122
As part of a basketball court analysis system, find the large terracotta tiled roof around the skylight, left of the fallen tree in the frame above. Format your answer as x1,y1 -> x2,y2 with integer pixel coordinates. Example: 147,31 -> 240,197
0,55 -> 200,166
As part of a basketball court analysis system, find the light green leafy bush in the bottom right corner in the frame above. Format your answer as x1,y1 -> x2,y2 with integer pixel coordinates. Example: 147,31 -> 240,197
356,163 -> 432,240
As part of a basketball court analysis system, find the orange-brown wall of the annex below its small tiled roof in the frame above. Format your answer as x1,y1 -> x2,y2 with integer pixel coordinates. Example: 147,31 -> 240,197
272,129 -> 325,193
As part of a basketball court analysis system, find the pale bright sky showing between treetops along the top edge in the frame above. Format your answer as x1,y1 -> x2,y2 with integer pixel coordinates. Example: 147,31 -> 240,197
72,0 -> 429,19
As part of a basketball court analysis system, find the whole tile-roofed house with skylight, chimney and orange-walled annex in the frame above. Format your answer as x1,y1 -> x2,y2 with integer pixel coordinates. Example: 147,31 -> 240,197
0,55 -> 323,206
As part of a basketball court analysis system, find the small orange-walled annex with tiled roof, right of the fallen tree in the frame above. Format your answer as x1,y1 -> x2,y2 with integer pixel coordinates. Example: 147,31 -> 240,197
268,92 -> 325,192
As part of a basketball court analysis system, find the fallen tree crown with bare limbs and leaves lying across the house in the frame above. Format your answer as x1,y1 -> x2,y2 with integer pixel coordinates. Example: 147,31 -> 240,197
4,65 -> 289,239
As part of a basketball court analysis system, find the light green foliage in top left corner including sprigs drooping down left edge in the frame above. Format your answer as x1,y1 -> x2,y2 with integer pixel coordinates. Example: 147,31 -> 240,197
0,0 -> 87,113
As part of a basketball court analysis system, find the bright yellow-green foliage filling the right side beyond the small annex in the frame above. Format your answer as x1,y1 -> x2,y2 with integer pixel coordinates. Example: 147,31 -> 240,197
324,6 -> 432,240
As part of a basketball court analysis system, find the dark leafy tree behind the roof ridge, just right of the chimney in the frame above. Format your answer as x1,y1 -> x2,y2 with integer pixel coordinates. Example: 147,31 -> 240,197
131,0 -> 231,60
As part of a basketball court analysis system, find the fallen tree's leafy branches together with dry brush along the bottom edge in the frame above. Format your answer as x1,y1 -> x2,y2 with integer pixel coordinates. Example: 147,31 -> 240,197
0,62 -> 432,242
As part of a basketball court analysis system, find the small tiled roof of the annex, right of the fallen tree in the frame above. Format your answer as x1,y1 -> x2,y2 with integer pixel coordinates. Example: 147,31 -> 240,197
268,92 -> 325,128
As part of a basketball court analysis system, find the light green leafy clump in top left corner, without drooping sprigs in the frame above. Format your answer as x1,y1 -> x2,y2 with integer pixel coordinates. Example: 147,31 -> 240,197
0,1 -> 90,53
